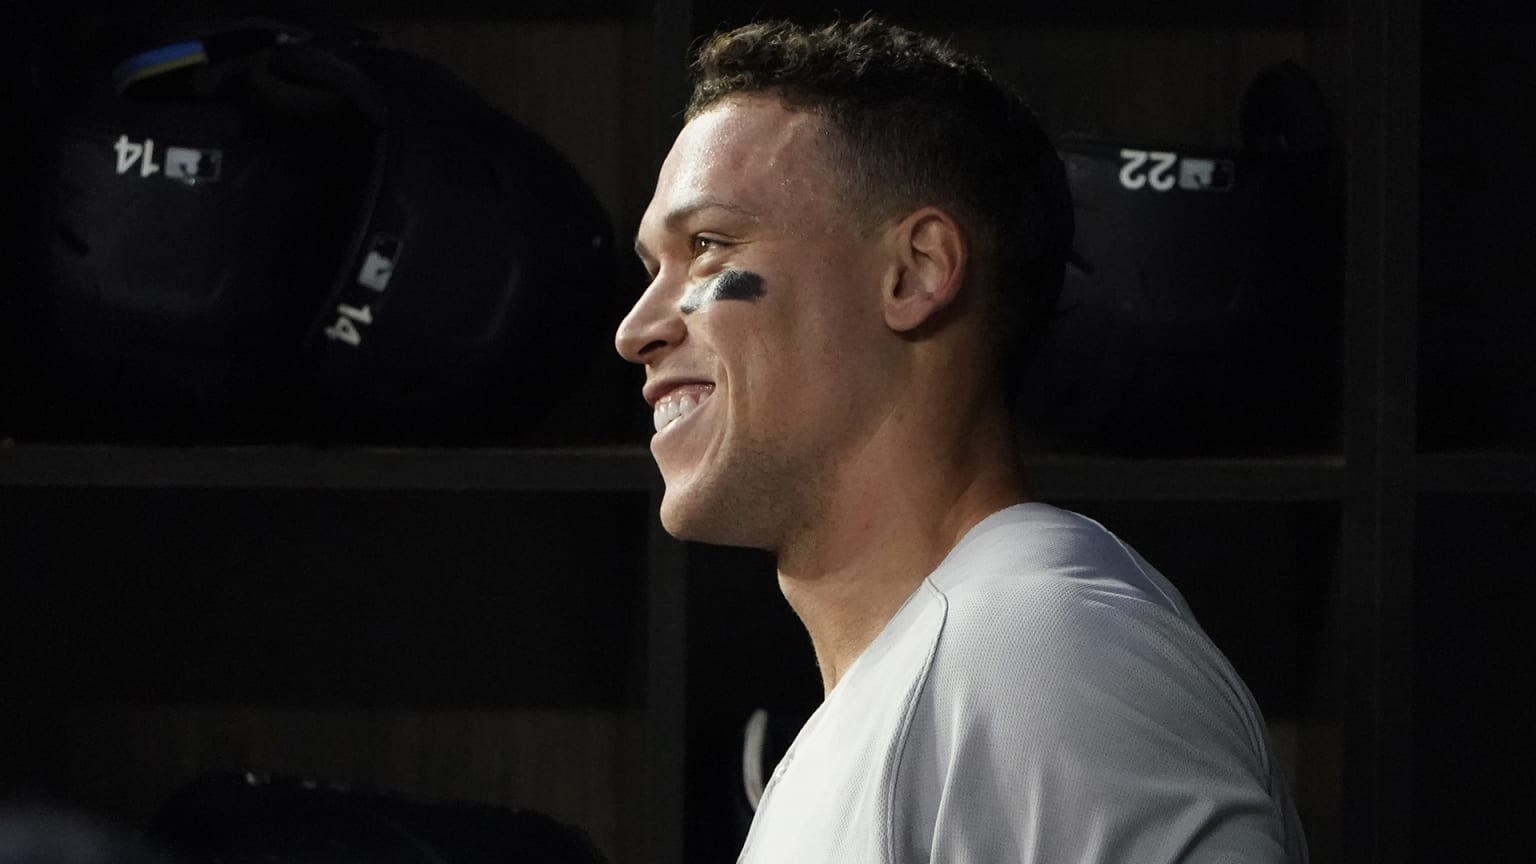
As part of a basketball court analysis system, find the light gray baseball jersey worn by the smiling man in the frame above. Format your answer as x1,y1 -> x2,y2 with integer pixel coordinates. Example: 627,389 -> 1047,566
740,503 -> 1307,864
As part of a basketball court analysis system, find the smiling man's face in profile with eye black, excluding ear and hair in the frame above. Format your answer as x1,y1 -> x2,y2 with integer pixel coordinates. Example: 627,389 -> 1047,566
616,95 -> 889,549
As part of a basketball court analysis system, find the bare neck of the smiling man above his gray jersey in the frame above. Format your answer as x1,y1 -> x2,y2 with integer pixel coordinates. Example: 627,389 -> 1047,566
779,402 -> 1028,693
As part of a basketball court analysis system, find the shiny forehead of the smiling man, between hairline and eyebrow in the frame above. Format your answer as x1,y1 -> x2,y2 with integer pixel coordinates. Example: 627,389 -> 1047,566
642,95 -> 834,232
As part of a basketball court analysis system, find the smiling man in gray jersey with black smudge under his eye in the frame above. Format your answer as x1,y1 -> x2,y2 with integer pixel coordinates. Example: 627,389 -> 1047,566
616,18 -> 1306,864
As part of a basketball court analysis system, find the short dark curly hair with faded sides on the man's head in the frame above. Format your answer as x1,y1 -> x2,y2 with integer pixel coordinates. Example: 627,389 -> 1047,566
687,15 -> 1072,382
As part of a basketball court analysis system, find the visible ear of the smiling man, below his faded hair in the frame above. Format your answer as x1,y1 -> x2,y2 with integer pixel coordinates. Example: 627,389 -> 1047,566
883,208 -> 969,334
